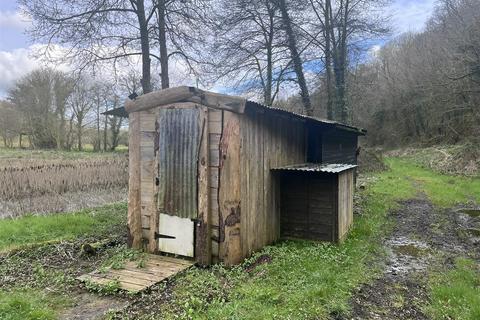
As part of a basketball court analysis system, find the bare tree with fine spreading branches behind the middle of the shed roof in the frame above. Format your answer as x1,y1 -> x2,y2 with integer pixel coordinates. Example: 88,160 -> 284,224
209,0 -> 291,105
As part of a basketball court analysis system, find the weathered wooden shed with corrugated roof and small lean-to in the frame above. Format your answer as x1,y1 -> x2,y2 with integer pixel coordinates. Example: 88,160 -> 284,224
125,87 -> 365,265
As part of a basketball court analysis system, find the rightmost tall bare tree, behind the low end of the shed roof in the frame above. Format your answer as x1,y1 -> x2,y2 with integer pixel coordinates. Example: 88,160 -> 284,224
307,0 -> 388,122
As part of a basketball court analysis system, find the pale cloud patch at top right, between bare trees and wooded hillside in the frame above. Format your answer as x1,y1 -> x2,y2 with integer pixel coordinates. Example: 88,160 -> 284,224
389,0 -> 437,34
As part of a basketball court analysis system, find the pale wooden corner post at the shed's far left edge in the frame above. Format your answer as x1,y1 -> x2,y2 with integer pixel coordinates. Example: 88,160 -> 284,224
127,112 -> 142,249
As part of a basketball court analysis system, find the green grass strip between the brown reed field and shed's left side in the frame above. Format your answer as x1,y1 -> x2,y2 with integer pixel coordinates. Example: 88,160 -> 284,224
0,203 -> 127,252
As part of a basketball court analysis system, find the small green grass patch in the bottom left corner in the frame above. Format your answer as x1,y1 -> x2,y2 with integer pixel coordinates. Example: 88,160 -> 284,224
0,289 -> 70,320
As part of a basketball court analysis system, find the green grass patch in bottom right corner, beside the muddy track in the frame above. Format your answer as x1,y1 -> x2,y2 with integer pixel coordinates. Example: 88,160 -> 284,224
426,258 -> 480,320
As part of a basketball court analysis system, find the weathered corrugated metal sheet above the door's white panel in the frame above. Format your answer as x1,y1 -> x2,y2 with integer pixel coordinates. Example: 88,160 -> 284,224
158,108 -> 201,218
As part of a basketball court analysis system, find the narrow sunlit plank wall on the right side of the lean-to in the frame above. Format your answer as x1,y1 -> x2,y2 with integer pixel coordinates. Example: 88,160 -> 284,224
338,170 -> 354,241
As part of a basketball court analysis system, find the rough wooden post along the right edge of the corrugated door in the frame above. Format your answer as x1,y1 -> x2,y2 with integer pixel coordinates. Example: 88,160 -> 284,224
195,107 -> 212,265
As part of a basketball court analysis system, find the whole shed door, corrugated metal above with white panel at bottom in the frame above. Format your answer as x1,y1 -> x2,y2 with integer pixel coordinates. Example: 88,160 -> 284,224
158,108 -> 201,257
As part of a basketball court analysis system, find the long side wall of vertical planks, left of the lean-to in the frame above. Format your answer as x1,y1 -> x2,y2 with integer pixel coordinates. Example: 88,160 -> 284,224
220,109 -> 305,264
